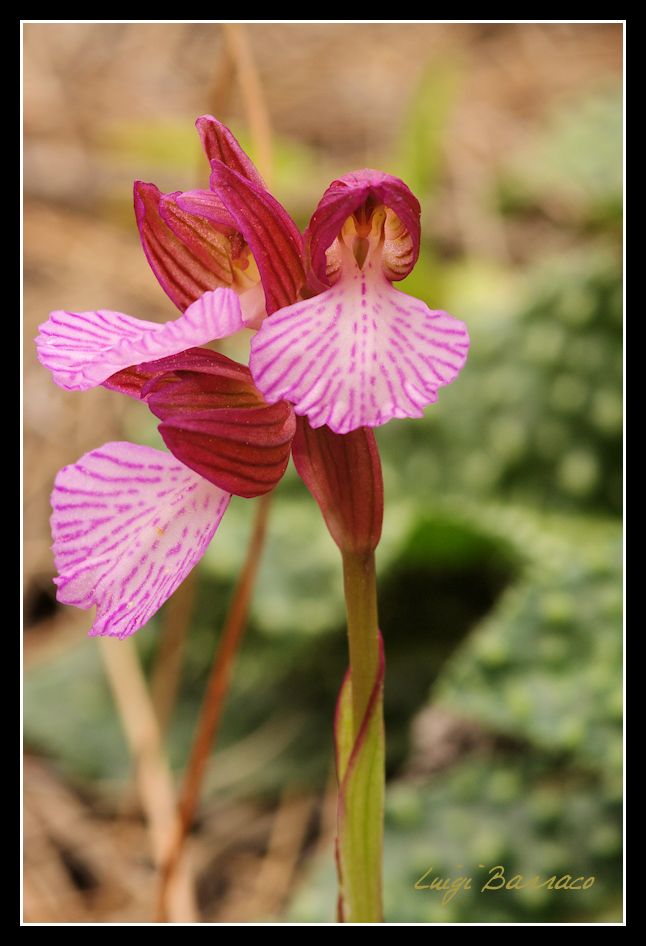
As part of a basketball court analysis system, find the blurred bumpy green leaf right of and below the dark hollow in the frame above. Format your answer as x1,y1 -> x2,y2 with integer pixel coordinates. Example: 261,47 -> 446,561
432,511 -> 623,781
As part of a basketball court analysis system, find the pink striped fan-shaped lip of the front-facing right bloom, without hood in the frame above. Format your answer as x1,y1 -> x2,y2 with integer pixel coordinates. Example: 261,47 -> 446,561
249,264 -> 469,434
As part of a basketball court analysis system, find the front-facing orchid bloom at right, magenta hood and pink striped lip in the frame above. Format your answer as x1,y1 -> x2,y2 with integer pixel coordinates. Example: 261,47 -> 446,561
249,170 -> 469,434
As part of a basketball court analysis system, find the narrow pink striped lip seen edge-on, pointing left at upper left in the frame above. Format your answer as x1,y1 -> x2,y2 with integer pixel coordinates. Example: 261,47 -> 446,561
36,289 -> 244,391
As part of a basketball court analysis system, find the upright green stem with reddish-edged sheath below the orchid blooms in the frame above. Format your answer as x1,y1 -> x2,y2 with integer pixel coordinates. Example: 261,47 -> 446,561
337,551 -> 385,923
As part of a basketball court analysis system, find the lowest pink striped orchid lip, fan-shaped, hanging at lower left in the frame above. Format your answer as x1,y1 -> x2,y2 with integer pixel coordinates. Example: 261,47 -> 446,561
51,443 -> 231,637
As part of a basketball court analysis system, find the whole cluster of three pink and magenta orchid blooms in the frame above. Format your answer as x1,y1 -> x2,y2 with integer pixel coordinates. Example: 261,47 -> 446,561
37,116 -> 468,637
